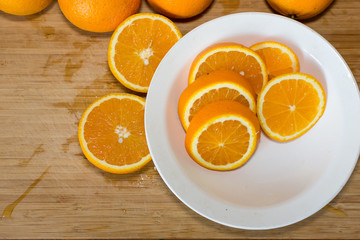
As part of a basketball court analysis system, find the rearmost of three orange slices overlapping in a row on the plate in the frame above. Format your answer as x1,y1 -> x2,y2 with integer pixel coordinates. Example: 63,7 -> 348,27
189,42 -> 268,94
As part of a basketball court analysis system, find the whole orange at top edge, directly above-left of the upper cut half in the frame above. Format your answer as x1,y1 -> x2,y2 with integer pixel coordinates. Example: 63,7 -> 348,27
58,0 -> 141,32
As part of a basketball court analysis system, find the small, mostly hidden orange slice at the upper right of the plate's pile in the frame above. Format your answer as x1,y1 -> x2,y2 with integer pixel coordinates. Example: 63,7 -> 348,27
250,41 -> 300,79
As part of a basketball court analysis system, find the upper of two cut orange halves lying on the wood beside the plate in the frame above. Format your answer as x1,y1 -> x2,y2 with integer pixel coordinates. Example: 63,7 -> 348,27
108,13 -> 181,92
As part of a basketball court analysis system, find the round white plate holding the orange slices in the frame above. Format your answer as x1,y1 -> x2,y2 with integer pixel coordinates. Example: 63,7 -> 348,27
145,13 -> 360,229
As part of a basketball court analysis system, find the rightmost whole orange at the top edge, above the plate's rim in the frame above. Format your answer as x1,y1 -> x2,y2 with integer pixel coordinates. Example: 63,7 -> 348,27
266,0 -> 333,19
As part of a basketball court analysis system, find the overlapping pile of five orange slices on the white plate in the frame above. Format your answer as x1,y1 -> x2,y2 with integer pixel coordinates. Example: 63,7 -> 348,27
178,41 -> 326,171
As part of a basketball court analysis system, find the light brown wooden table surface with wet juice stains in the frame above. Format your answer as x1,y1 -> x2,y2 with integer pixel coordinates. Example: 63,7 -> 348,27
0,0 -> 360,239
